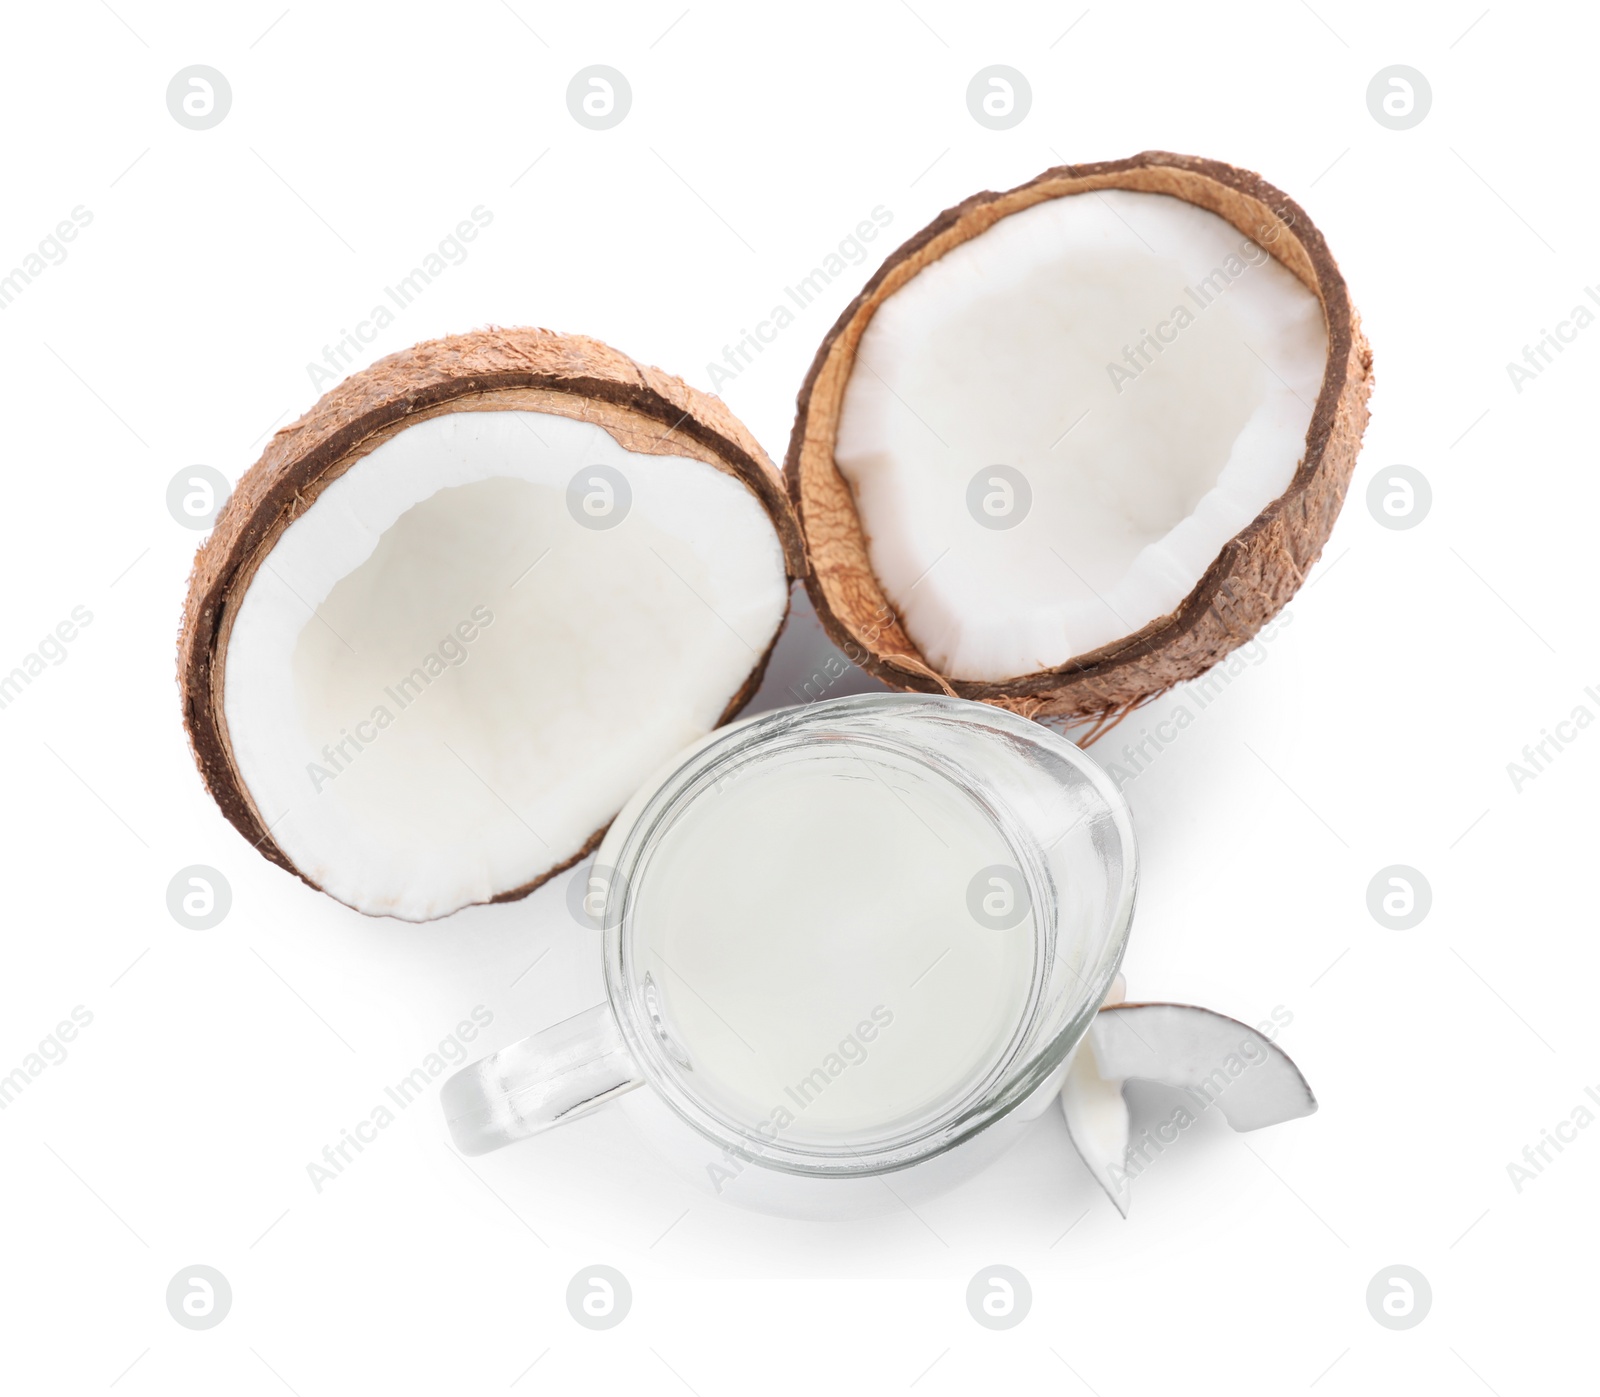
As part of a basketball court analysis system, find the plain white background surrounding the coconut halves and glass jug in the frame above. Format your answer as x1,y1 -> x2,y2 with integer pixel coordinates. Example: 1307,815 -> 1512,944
0,0 -> 1600,1397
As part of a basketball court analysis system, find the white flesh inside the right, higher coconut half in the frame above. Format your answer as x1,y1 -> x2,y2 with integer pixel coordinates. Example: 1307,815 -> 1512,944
834,190 -> 1326,680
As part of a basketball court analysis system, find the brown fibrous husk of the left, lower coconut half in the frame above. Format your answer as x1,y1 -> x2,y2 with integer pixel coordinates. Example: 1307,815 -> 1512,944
178,328 -> 805,903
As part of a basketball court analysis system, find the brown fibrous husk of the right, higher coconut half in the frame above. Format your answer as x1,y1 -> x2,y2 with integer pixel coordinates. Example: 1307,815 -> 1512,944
784,150 -> 1373,736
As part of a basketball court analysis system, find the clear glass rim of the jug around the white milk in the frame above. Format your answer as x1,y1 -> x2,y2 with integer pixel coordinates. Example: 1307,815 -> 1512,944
603,693 -> 1138,1178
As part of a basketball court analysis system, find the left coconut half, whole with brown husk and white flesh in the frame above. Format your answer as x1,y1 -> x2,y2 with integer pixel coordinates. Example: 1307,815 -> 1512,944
179,330 -> 803,920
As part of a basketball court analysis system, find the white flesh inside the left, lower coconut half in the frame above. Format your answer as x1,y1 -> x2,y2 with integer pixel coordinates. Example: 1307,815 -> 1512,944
224,411 -> 789,920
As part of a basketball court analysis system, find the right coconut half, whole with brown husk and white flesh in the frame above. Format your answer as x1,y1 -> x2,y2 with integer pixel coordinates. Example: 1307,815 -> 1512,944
786,154 -> 1371,719
